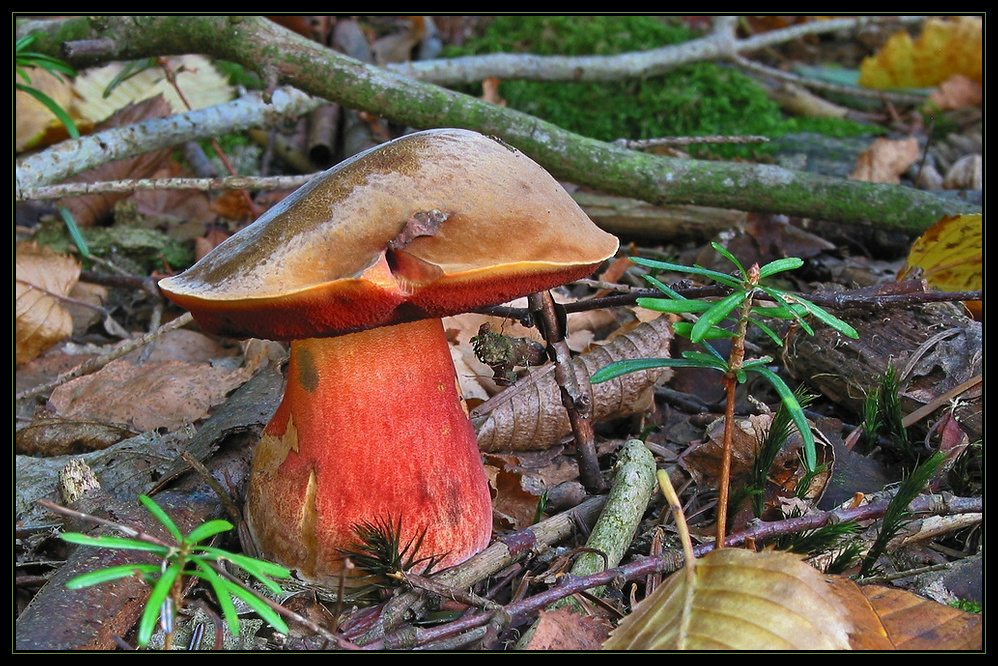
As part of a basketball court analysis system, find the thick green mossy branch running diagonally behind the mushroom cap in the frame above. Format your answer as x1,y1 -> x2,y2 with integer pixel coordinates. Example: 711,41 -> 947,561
19,15 -> 976,233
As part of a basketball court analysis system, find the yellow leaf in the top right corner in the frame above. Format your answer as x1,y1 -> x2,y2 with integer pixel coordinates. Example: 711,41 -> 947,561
859,16 -> 984,90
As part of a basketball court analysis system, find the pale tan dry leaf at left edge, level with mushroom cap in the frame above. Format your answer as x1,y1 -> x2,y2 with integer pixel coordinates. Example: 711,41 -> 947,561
14,242 -> 80,365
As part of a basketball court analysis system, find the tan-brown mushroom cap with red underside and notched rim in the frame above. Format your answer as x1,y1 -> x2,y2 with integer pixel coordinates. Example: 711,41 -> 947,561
159,129 -> 618,340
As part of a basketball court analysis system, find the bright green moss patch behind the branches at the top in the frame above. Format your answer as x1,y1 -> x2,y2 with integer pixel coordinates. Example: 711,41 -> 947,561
445,16 -> 873,157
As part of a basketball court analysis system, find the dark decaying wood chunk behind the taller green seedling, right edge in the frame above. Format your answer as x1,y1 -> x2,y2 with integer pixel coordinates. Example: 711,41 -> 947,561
784,303 -> 984,441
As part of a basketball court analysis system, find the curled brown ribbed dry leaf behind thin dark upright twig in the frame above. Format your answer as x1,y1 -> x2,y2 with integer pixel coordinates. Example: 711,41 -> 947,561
472,317 -> 672,451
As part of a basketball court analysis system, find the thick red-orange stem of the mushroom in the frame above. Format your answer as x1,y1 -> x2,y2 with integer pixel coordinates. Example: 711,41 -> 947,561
247,319 -> 492,585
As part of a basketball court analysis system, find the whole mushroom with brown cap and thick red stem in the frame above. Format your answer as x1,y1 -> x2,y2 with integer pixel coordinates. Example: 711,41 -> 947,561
159,129 -> 618,584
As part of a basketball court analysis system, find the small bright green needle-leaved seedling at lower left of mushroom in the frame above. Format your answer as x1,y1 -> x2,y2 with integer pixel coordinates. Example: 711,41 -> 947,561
62,495 -> 291,647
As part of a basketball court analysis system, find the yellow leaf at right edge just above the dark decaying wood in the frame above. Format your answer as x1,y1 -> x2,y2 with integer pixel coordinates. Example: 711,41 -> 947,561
898,215 -> 984,319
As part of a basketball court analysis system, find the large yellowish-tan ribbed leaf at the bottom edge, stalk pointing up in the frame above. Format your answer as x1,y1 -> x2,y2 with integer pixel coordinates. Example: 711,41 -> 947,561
603,548 -> 854,650
